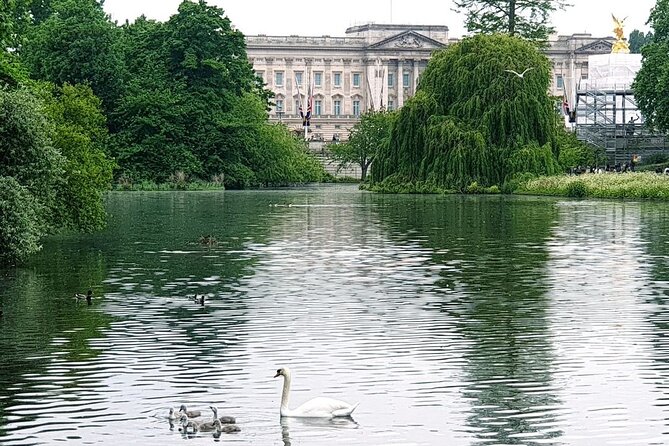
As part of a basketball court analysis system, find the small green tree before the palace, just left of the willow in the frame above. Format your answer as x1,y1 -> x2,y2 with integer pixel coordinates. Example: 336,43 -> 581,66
328,111 -> 397,181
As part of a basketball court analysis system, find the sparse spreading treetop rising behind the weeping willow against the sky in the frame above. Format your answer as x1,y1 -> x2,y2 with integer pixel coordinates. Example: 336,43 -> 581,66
454,0 -> 568,41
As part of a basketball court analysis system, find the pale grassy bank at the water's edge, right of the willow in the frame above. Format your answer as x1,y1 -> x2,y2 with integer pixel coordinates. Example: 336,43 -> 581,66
514,172 -> 669,200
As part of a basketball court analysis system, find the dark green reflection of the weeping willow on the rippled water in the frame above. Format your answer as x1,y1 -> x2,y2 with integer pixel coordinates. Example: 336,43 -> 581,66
370,197 -> 561,444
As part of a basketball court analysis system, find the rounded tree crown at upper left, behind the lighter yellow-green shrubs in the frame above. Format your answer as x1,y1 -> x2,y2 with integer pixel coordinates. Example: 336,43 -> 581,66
21,0 -> 125,112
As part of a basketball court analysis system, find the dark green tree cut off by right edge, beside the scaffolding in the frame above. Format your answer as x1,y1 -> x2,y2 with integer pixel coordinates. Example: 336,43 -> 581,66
632,0 -> 669,131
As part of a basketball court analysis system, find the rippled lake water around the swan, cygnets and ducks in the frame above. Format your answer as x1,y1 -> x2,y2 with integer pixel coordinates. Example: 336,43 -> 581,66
0,185 -> 669,446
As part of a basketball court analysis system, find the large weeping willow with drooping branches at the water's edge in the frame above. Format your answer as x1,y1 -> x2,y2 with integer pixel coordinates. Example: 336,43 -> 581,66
371,35 -> 560,190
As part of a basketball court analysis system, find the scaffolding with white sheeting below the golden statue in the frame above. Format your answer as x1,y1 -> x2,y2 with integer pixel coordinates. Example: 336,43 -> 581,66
572,85 -> 669,165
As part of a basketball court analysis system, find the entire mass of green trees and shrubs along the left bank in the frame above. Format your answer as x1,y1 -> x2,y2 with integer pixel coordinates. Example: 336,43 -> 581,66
0,0 -> 325,263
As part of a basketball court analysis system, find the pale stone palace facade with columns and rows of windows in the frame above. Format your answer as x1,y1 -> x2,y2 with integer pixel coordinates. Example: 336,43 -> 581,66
246,24 -> 615,141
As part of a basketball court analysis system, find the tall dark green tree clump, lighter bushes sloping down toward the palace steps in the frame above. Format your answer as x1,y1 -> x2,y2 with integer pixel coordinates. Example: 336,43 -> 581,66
105,1 -> 324,188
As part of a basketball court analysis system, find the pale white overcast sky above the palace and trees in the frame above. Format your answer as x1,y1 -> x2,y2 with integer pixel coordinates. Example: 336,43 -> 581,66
104,0 -> 655,37
